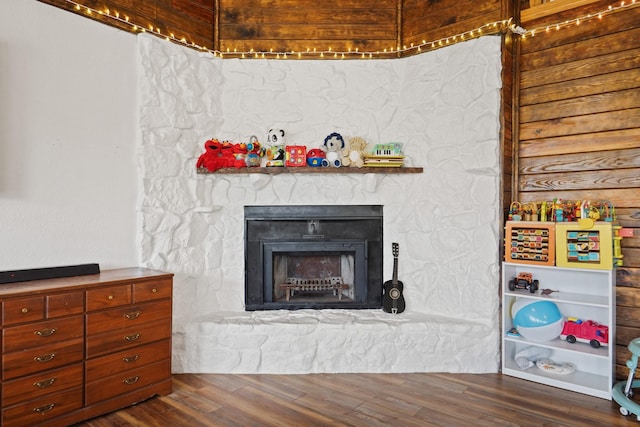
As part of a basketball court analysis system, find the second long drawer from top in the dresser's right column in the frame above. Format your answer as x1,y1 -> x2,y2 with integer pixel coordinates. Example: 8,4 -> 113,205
87,318 -> 171,359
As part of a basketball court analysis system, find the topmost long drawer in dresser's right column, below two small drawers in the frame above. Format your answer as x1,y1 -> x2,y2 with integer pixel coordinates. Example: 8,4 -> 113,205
87,300 -> 171,335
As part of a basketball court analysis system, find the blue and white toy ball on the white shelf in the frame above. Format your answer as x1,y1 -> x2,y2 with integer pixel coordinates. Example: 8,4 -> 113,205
511,298 -> 564,342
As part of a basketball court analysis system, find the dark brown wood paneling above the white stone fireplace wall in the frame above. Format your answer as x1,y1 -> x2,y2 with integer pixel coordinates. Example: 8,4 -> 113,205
39,0 -> 508,59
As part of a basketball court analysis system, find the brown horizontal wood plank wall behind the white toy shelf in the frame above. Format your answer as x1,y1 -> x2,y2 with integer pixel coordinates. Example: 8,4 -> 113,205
514,1 -> 640,378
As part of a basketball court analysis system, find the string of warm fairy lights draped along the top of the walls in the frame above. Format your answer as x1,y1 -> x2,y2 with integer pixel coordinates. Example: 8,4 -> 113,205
58,0 -> 640,59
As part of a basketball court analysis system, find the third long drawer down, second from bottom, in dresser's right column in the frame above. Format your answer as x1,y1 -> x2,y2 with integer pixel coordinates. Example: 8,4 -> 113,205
85,340 -> 171,382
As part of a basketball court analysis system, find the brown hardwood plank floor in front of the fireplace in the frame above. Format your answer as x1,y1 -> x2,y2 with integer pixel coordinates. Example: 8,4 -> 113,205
77,374 -> 639,427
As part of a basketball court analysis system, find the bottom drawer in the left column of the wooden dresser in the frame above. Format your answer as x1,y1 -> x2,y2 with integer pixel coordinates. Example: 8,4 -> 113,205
2,387 -> 82,427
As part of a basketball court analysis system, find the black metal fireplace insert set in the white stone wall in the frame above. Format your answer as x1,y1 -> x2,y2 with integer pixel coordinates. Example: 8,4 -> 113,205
244,205 -> 383,311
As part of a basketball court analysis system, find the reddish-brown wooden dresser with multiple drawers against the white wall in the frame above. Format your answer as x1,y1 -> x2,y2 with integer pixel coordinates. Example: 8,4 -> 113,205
0,268 -> 173,427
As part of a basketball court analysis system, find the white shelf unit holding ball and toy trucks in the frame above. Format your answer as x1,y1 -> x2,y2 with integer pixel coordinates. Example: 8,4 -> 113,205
502,262 -> 616,400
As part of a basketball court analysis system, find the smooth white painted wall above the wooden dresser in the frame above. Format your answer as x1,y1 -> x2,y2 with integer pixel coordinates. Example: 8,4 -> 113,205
0,0 -> 139,270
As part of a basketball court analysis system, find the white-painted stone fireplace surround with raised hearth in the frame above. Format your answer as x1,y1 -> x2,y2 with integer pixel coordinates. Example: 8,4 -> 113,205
138,35 -> 500,373
